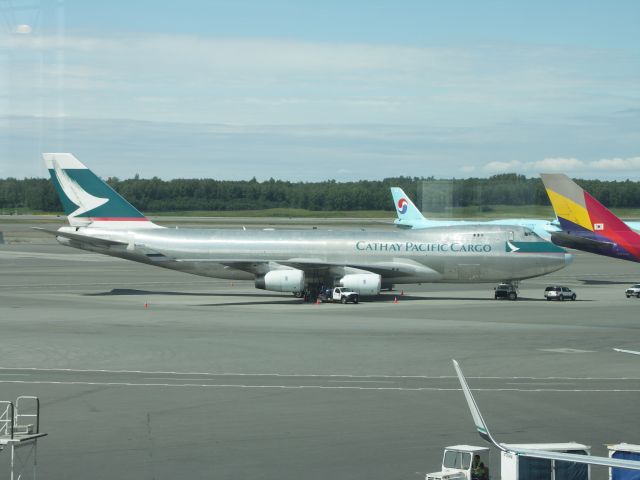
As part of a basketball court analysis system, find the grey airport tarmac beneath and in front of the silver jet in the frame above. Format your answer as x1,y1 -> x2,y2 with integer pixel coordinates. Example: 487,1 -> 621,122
0,224 -> 640,479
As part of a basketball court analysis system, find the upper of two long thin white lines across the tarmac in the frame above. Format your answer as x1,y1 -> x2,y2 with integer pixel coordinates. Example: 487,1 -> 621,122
0,367 -> 640,382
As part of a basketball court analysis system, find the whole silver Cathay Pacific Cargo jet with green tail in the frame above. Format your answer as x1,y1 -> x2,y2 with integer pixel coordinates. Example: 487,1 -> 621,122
40,153 -> 572,298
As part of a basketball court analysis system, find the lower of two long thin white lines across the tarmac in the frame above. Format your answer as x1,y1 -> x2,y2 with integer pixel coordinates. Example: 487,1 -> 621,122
0,380 -> 640,393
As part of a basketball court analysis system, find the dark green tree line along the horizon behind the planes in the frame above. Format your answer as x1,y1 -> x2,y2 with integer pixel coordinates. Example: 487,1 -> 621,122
0,174 -> 640,212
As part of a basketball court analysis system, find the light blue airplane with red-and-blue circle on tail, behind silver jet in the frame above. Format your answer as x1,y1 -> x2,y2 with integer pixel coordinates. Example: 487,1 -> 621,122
391,187 -> 560,240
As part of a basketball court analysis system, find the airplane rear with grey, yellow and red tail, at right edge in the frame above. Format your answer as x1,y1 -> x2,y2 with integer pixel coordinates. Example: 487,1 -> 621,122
540,173 -> 640,262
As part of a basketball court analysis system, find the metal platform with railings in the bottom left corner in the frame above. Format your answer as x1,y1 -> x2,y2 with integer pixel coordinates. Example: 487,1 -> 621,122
0,396 -> 47,480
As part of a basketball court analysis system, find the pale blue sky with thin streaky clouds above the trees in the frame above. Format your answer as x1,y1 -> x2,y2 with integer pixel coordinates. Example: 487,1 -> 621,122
0,0 -> 640,181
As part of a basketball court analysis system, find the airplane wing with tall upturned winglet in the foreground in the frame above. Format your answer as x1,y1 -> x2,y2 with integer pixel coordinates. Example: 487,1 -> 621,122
453,360 -> 640,470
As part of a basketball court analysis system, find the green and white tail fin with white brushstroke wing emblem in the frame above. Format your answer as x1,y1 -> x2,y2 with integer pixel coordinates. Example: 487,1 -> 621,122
42,153 -> 158,228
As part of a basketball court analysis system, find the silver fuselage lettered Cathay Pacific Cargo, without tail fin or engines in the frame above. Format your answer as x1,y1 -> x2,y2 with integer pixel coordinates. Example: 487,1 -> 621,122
58,224 -> 571,286
